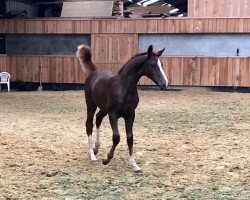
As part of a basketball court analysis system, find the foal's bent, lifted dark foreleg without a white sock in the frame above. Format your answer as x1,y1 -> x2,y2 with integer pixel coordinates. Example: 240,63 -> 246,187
102,115 -> 120,165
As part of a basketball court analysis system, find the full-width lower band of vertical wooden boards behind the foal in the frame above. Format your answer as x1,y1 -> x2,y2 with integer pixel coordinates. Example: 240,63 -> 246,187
0,56 -> 250,87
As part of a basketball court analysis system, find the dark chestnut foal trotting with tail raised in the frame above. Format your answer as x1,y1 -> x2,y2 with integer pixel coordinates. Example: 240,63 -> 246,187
76,45 -> 168,172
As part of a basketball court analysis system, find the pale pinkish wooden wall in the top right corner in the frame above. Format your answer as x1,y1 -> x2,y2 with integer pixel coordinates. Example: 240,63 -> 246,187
188,0 -> 250,17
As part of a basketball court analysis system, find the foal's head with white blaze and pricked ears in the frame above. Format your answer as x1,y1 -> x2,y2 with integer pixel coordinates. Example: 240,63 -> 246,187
142,45 -> 168,90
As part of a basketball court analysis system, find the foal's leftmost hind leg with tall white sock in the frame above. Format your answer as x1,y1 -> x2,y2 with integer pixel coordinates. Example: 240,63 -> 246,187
86,105 -> 97,161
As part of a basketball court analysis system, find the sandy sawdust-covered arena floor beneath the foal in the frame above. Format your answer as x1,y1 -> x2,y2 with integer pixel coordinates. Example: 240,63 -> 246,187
0,88 -> 250,200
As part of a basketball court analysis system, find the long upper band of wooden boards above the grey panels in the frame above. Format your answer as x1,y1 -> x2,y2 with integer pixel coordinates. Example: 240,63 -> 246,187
0,18 -> 250,34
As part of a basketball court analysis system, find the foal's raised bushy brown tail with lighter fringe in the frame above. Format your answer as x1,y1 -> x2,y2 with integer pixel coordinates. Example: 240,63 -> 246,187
76,44 -> 96,74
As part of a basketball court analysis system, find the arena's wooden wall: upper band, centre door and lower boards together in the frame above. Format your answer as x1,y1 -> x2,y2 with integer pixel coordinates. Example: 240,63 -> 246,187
0,18 -> 250,87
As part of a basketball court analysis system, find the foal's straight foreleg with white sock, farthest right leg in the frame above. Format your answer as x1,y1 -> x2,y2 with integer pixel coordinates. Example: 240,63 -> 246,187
125,112 -> 142,173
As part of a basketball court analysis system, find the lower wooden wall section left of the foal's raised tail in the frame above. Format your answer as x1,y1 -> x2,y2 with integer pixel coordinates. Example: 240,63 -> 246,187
6,56 -> 86,83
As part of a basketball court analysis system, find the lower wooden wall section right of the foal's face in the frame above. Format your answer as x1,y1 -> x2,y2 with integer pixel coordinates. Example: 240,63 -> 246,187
163,57 -> 250,87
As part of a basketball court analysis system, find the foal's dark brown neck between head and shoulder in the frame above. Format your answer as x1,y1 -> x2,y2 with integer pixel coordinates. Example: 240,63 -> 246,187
118,56 -> 145,88
